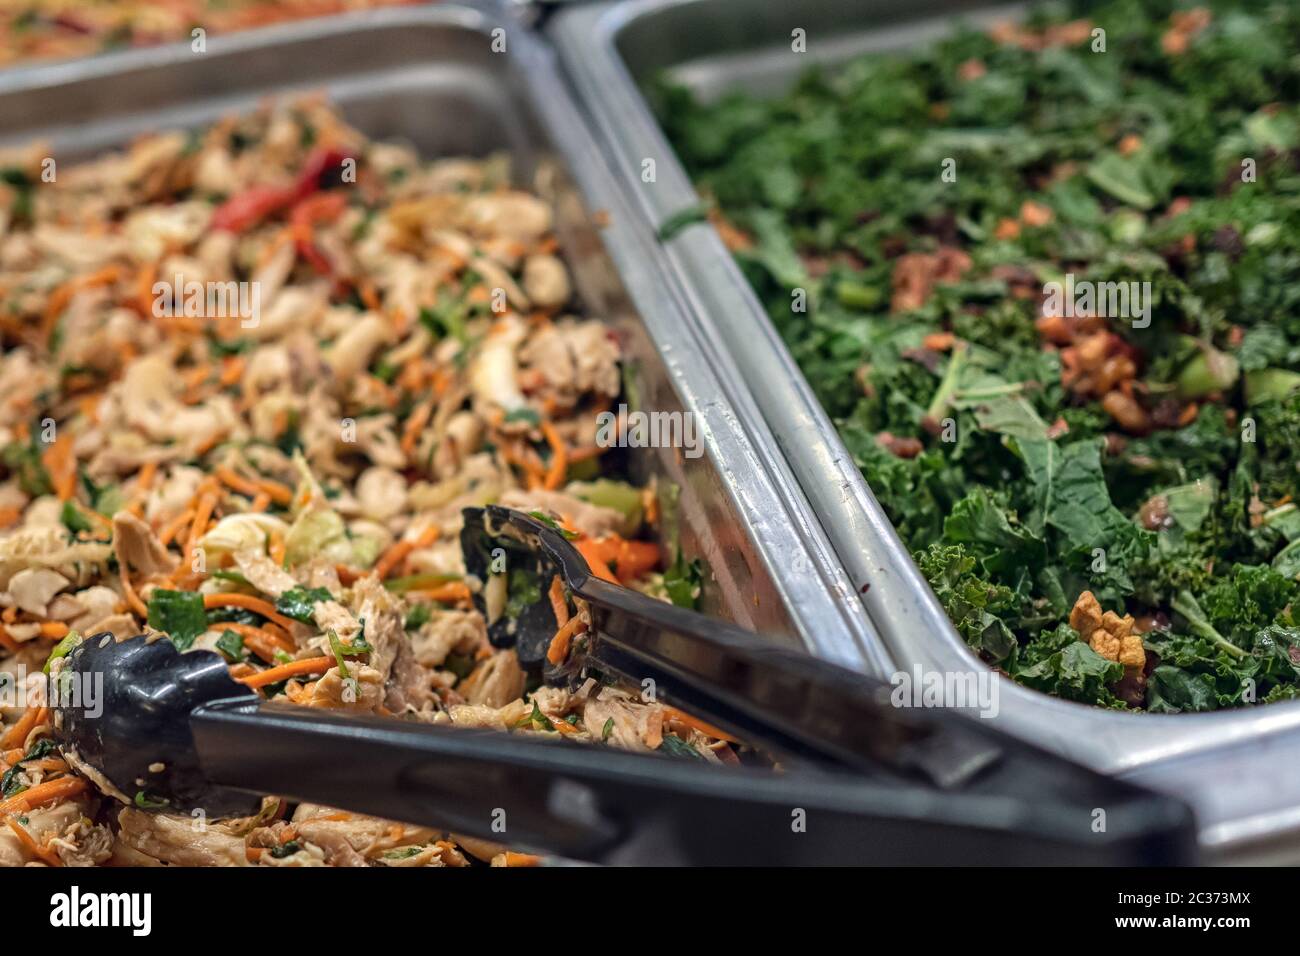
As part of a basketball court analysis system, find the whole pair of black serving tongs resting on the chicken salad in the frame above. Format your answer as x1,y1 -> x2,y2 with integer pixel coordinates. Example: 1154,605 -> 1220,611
55,507 -> 1195,865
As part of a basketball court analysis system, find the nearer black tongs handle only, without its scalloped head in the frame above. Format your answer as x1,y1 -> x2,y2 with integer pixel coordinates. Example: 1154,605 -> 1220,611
191,701 -> 1188,865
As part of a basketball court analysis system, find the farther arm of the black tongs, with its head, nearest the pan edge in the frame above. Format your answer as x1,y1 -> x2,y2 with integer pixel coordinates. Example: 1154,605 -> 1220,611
462,506 -> 998,786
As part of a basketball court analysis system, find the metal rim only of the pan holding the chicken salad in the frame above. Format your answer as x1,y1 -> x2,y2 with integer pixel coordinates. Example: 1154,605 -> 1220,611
0,0 -> 889,675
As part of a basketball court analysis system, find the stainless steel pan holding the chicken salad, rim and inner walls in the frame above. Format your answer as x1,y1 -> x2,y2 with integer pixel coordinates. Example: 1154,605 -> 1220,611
0,4 -> 888,674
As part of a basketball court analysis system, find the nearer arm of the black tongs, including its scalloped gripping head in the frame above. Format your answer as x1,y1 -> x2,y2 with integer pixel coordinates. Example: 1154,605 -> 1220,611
53,632 -> 1188,864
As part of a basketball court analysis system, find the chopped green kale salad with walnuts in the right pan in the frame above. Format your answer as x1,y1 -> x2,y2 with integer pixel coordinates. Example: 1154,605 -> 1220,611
651,0 -> 1300,713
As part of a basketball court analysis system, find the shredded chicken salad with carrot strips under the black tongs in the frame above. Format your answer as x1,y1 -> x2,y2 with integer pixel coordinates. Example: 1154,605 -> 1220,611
0,100 -> 722,866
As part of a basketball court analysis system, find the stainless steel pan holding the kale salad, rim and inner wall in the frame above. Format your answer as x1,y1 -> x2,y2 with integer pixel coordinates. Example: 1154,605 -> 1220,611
547,0 -> 1300,856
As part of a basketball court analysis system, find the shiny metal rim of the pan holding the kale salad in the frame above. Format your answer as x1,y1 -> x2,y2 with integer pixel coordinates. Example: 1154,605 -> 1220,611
551,0 -> 1300,853
